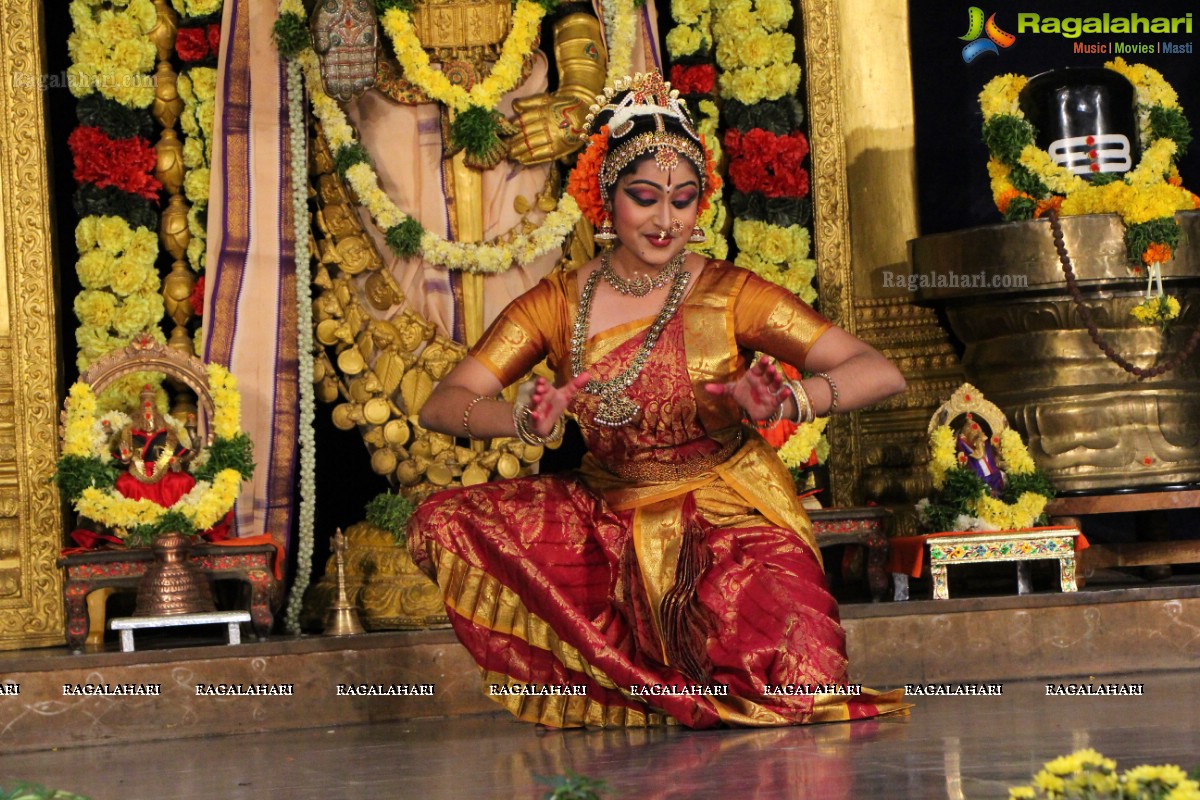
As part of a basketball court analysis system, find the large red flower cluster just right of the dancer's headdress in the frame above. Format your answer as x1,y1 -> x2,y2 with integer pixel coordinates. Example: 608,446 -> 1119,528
724,128 -> 809,197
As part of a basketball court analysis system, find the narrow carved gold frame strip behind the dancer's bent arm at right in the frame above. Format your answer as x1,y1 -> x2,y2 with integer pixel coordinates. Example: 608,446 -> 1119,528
799,0 -> 862,506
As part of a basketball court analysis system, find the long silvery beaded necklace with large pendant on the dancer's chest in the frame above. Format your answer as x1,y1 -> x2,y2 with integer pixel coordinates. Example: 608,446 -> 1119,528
571,258 -> 691,428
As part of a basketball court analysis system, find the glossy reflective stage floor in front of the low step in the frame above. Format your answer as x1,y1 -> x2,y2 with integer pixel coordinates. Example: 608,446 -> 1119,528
0,671 -> 1200,800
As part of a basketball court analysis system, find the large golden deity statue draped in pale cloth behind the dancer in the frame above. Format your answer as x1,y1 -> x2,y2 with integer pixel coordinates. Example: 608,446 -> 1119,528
304,0 -> 655,344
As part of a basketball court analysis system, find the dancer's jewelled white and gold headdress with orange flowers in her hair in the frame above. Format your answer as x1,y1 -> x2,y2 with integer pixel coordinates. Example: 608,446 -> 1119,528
566,72 -> 720,231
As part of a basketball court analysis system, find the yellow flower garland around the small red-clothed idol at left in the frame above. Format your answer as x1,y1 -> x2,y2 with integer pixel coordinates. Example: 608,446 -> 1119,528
62,363 -> 242,531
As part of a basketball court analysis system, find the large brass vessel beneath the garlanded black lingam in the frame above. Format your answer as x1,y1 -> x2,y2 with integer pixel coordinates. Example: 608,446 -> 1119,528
910,211 -> 1200,493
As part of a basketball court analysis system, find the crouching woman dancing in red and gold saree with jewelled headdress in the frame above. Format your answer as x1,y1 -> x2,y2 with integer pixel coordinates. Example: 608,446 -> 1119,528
409,74 -> 905,728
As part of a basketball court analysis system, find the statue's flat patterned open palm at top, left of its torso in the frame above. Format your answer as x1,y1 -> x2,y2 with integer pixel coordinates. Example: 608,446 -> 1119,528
312,0 -> 379,102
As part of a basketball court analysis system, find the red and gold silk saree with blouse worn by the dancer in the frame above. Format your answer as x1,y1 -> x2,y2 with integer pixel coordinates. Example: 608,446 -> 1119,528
409,261 -> 905,728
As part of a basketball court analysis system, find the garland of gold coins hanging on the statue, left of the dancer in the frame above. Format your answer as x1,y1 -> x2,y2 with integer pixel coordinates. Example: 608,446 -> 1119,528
311,122 -> 552,496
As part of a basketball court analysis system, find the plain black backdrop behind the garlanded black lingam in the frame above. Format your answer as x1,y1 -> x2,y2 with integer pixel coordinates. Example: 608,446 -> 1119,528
908,0 -> 1200,234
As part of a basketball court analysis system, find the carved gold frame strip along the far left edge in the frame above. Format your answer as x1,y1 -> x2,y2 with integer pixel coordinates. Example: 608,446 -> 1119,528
0,0 -> 64,649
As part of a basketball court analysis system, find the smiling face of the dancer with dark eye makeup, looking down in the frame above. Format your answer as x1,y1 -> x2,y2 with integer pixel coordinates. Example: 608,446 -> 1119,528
613,157 -> 700,271
